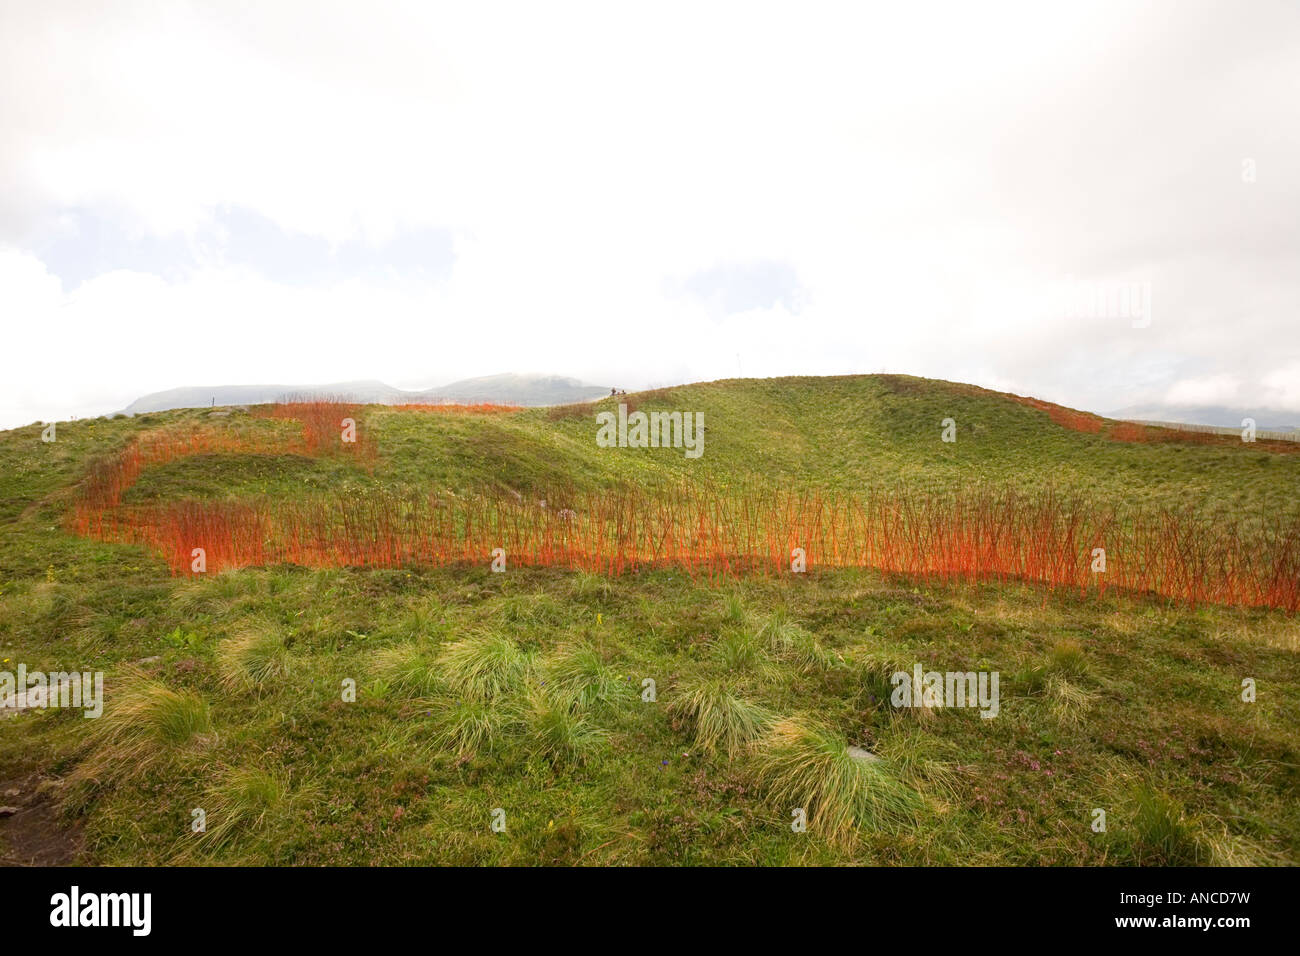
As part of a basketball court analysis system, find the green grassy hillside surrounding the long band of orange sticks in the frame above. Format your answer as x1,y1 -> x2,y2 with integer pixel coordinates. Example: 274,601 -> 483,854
0,376 -> 1300,864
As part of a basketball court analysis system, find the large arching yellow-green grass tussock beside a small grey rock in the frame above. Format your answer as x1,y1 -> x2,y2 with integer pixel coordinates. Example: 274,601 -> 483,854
755,719 -> 920,844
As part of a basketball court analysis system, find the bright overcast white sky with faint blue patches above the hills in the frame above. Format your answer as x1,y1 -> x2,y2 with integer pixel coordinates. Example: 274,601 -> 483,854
0,0 -> 1300,427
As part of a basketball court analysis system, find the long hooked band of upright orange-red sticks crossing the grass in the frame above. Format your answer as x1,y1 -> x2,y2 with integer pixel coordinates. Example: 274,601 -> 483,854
69,418 -> 1300,611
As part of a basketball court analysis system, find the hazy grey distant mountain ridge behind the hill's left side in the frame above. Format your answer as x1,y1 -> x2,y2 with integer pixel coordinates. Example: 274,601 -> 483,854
122,372 -> 610,415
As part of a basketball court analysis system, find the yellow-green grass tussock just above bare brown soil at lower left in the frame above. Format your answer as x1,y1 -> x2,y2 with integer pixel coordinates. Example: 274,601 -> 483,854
73,678 -> 212,782
